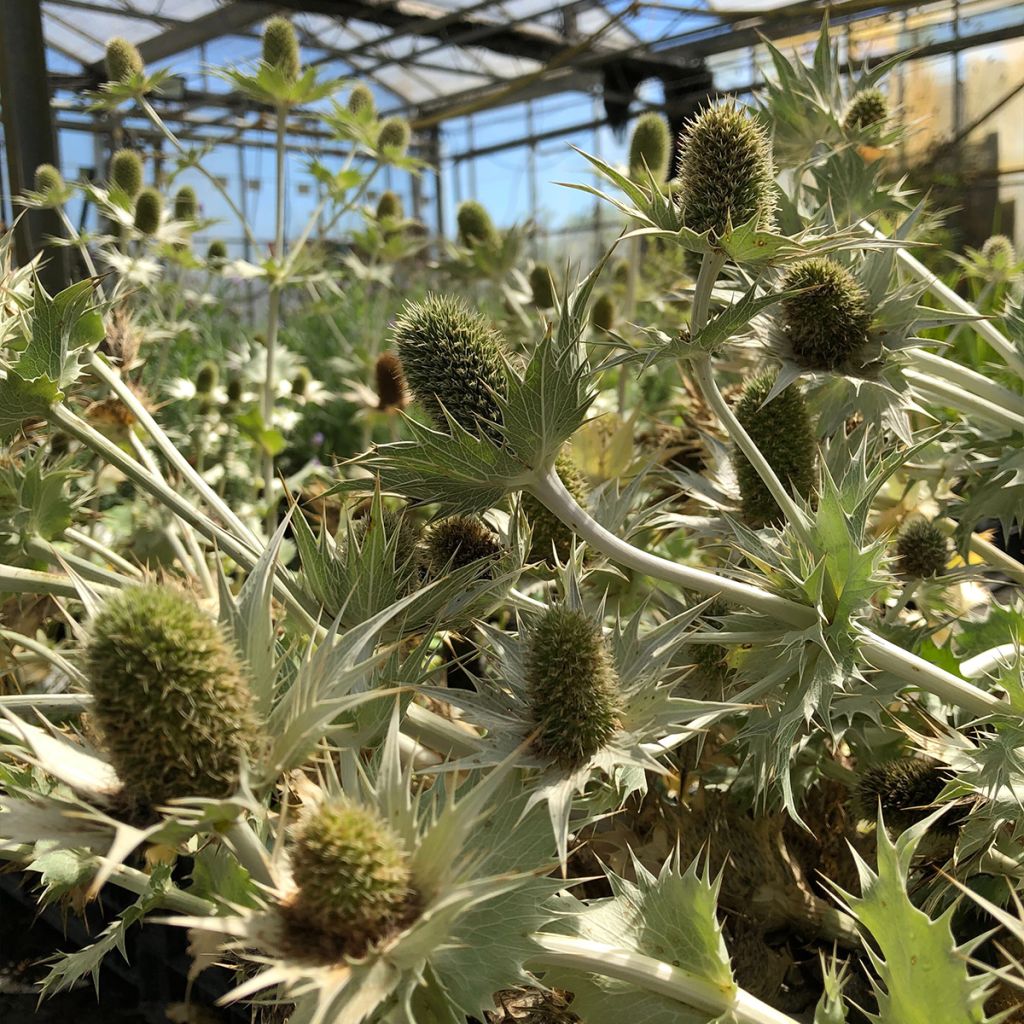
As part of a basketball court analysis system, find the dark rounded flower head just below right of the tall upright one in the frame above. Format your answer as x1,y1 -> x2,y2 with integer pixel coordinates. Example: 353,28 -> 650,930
782,256 -> 871,372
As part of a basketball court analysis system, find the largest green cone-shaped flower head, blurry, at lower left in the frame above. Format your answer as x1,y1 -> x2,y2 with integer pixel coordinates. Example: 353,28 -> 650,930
85,584 -> 258,807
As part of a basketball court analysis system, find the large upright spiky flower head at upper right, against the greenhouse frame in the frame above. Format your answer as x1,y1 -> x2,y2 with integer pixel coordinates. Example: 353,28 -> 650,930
679,102 -> 775,236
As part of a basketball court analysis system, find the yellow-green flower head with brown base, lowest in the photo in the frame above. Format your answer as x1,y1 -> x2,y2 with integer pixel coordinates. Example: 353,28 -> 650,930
286,799 -> 413,952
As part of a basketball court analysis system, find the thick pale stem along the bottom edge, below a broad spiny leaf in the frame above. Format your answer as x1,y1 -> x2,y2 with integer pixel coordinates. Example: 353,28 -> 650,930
531,933 -> 798,1024
